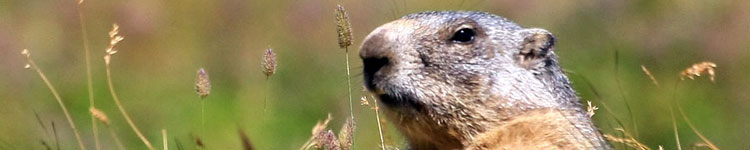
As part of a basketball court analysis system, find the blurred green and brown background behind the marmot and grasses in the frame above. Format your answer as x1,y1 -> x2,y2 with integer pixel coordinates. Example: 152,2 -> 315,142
0,0 -> 750,149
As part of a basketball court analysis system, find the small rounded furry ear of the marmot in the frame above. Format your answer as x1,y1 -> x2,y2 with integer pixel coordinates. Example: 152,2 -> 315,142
516,28 -> 555,69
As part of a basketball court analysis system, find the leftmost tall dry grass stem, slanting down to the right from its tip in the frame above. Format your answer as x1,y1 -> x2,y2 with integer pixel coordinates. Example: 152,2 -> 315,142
21,49 -> 86,150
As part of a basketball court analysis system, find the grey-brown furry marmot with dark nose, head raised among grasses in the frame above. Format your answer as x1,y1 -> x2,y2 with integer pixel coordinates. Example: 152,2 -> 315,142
359,11 -> 611,150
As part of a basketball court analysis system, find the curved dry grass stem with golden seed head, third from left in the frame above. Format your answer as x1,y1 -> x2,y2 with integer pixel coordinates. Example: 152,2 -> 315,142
104,24 -> 155,150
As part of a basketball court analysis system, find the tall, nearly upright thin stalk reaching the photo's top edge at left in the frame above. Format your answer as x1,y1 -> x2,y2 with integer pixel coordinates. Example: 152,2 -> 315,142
76,3 -> 102,150
